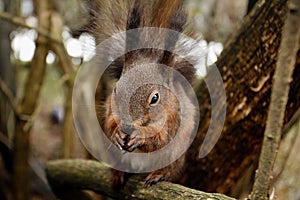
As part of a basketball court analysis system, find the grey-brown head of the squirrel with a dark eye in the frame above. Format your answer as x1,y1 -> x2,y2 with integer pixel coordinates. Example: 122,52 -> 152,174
111,64 -> 179,134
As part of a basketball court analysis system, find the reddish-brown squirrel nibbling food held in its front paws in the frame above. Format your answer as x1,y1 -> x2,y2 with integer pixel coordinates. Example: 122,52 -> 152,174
80,0 -> 197,187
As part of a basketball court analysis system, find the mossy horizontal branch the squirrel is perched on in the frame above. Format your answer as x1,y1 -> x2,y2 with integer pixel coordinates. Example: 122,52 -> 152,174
46,159 -> 233,200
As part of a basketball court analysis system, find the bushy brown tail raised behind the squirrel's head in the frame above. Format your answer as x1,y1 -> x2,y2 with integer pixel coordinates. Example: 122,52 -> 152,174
79,0 -> 195,83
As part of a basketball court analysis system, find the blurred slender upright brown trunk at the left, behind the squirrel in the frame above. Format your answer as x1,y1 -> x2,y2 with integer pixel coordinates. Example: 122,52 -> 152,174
13,0 -> 51,200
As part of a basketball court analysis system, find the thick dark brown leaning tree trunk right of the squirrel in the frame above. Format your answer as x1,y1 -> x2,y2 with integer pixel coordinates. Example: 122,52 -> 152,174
181,0 -> 300,194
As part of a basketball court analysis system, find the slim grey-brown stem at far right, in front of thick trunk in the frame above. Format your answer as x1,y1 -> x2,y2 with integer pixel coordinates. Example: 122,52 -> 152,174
251,0 -> 300,200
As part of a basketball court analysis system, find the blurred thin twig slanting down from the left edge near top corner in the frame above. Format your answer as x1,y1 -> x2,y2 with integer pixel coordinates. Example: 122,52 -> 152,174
0,12 -> 62,44
